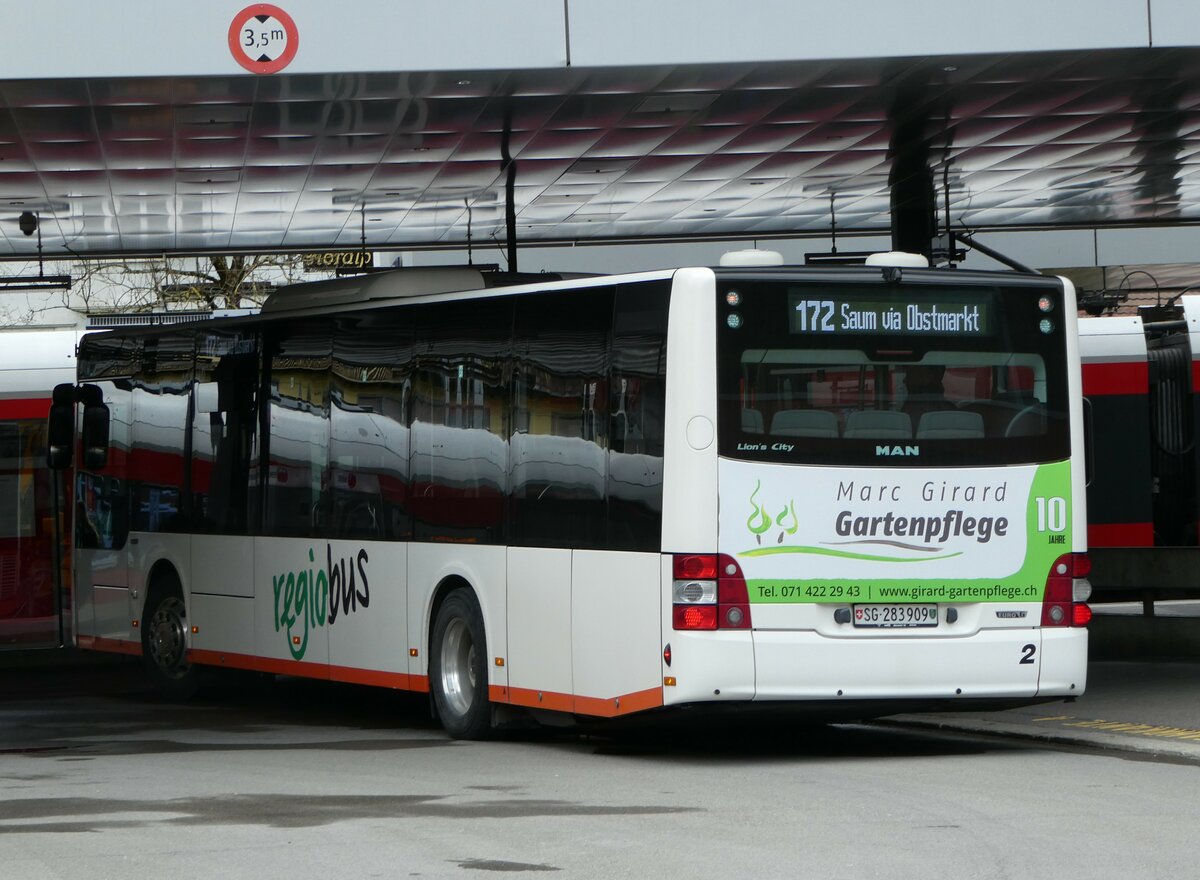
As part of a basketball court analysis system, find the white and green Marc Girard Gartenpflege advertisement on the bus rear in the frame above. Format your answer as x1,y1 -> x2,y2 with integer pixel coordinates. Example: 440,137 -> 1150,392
720,447 -> 1072,603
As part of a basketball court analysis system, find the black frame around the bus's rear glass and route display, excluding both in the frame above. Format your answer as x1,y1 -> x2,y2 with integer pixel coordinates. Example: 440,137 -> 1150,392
715,269 -> 1072,467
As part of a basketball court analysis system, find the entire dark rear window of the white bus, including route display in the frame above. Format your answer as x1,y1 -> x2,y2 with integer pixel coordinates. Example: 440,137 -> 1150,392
718,281 -> 1070,466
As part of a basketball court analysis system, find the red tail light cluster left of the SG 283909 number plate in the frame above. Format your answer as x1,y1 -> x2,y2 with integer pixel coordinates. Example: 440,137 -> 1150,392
671,553 -> 750,629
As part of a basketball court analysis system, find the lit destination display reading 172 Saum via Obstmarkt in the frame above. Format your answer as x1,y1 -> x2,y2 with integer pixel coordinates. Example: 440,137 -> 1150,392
788,289 -> 992,336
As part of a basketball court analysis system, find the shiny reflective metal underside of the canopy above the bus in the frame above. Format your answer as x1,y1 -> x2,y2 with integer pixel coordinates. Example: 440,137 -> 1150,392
0,48 -> 1200,258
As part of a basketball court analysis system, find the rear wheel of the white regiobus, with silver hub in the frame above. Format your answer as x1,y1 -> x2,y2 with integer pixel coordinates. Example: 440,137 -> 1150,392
430,589 -> 492,740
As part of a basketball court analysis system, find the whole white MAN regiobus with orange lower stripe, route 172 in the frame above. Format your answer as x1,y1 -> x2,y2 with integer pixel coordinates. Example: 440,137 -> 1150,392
49,252 -> 1091,737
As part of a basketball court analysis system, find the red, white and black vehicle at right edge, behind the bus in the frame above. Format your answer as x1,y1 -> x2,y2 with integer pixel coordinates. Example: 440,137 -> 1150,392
1079,297 -> 1200,601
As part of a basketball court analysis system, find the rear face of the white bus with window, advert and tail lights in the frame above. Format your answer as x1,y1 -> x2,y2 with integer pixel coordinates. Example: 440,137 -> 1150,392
664,269 -> 1090,711
